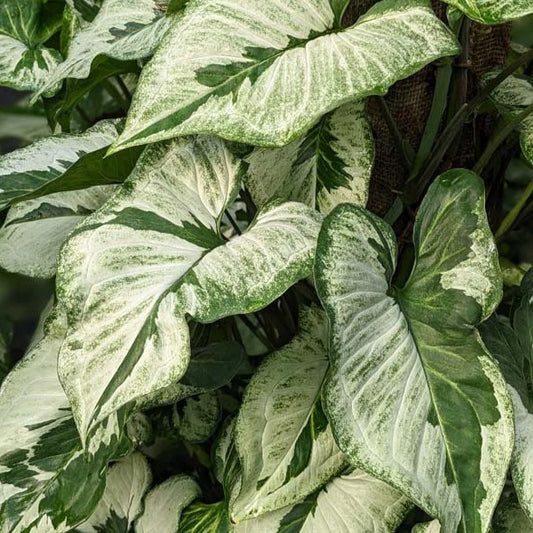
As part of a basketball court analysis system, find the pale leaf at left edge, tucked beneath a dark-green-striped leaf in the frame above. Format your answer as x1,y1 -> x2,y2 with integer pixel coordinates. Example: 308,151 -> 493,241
0,185 -> 116,278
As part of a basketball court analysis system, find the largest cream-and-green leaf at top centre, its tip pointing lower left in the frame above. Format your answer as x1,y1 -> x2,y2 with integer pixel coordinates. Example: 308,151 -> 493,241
111,0 -> 459,149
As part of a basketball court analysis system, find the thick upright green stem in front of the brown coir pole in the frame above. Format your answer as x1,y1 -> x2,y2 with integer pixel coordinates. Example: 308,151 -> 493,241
407,64 -> 452,181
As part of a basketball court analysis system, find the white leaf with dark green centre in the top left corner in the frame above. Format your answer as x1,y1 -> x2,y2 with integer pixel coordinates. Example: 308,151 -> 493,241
0,0 -> 62,91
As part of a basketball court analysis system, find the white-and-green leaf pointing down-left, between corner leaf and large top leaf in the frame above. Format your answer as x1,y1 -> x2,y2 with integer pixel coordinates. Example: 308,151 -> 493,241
38,0 -> 169,94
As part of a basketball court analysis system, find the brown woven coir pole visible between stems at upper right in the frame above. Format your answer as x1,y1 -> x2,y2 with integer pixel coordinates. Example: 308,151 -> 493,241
344,0 -> 511,215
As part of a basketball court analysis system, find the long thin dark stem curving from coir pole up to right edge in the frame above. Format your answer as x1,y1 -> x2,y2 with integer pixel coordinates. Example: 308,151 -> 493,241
405,49 -> 533,204
